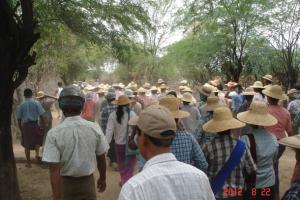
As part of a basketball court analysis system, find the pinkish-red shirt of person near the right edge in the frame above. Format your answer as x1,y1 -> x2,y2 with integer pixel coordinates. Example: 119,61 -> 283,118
265,105 -> 292,140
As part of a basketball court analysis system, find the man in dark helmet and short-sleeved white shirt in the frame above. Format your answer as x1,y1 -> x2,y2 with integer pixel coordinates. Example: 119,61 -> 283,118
42,86 -> 109,200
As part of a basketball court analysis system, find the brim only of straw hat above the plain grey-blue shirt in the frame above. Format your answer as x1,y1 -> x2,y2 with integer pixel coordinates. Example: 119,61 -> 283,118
237,111 -> 278,126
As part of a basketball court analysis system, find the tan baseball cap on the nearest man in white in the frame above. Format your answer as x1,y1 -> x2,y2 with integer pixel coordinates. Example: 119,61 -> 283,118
137,105 -> 176,139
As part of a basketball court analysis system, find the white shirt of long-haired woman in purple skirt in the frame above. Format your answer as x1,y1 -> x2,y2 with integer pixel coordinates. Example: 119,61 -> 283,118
105,108 -> 135,144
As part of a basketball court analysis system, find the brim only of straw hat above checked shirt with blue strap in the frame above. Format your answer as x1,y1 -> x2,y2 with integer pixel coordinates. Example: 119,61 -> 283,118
203,118 -> 245,133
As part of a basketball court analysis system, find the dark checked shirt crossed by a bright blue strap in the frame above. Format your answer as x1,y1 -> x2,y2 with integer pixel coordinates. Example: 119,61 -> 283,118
203,135 -> 256,198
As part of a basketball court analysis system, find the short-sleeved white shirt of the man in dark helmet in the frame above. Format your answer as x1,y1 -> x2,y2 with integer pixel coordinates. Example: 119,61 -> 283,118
43,116 -> 109,177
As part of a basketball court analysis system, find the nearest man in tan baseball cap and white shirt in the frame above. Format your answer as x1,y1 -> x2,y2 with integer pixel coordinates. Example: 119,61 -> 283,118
119,105 -> 215,200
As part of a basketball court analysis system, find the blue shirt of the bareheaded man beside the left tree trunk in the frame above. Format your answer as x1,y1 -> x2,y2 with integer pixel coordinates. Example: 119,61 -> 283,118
17,98 -> 45,123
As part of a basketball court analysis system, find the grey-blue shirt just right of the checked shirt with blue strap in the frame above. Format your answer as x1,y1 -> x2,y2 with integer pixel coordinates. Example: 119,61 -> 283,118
242,128 -> 278,188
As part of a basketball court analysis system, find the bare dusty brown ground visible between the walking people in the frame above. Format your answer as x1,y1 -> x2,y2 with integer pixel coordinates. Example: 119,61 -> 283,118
14,110 -> 295,200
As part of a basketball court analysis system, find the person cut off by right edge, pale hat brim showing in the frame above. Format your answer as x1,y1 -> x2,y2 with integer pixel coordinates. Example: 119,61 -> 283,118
279,134 -> 300,200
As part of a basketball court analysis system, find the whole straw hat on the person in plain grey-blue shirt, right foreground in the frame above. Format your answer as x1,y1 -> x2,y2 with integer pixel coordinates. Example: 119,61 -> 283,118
237,101 -> 277,126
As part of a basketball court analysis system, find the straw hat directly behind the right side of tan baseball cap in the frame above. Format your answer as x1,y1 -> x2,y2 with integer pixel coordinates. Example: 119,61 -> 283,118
159,96 -> 190,119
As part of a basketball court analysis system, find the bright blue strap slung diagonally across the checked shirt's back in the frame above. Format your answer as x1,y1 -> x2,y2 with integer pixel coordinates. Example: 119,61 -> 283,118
211,140 -> 246,194
